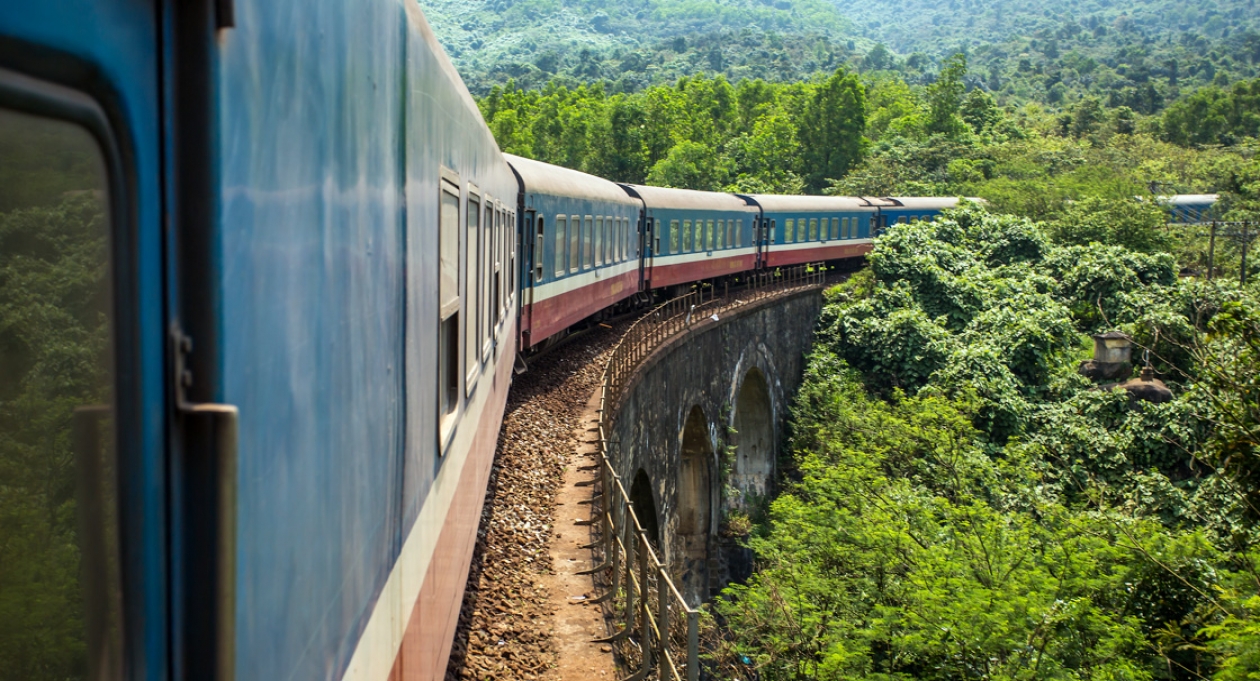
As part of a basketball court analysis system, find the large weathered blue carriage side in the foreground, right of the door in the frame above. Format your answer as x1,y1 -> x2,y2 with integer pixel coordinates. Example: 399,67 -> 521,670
217,0 -> 519,680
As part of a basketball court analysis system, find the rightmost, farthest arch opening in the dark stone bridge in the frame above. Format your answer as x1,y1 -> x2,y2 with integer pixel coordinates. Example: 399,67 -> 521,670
731,367 -> 775,507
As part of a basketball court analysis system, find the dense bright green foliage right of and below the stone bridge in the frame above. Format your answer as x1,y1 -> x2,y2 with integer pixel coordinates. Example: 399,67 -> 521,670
713,203 -> 1260,680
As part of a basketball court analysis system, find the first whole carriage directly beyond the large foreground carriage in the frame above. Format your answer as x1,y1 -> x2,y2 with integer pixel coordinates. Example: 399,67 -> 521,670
505,154 -> 641,349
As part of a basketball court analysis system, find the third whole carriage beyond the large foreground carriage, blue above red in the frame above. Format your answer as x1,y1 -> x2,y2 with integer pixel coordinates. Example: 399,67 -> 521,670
741,194 -> 877,267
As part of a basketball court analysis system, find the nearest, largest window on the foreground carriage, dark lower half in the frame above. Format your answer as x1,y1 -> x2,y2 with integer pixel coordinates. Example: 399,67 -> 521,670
437,179 -> 460,433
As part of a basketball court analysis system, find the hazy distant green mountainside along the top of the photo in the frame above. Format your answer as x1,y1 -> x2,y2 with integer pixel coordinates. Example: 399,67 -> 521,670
421,0 -> 1260,112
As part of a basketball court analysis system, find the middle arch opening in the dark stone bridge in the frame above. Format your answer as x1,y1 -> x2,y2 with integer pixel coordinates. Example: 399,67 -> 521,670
678,406 -> 713,604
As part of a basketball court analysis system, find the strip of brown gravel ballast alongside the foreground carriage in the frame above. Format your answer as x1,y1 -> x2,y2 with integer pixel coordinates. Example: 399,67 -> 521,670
446,317 -> 634,681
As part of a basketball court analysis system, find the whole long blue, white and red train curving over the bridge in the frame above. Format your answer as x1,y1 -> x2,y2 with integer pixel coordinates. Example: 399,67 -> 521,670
0,0 -> 1219,681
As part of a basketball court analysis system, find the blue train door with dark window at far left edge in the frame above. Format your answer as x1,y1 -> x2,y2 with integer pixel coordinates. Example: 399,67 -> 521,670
0,0 -> 234,680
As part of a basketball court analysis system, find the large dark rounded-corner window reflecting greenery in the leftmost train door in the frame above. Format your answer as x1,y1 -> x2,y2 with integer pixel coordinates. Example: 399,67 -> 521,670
0,107 -> 122,678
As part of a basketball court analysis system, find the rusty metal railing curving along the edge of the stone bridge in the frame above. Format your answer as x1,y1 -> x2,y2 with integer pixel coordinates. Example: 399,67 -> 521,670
581,265 -> 825,681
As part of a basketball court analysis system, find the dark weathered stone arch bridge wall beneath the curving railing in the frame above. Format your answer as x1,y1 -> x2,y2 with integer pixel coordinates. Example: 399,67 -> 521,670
604,286 -> 823,607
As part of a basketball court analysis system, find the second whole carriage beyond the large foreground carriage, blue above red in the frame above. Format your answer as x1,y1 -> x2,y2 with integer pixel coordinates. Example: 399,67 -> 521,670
622,184 -> 757,290
